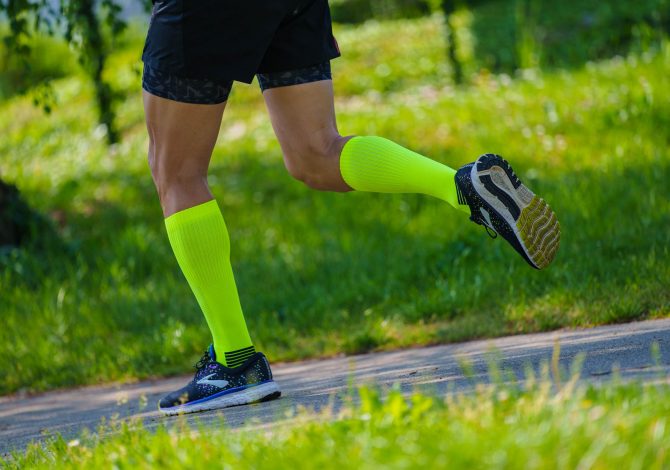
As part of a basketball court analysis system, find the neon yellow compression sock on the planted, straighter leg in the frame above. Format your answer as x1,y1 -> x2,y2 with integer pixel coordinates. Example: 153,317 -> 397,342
165,199 -> 255,367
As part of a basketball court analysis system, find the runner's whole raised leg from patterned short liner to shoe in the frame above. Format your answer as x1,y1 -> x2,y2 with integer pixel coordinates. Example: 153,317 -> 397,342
259,68 -> 560,269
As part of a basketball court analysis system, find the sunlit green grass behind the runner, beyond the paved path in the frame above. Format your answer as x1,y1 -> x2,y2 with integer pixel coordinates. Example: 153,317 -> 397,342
0,18 -> 670,393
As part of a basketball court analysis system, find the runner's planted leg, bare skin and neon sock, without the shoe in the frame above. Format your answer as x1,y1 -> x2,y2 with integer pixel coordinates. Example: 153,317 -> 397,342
143,91 -> 254,367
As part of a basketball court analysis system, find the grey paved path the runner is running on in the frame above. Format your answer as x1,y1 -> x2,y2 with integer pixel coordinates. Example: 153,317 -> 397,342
0,319 -> 670,454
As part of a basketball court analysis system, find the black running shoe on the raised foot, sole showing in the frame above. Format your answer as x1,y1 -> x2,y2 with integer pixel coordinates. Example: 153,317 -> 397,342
455,153 -> 561,269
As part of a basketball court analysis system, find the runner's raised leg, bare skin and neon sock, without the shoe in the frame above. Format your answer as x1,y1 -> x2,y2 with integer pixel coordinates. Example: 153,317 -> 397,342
263,80 -> 470,214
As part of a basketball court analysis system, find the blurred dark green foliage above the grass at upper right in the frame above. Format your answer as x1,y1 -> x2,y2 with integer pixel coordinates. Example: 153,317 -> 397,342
331,0 -> 670,73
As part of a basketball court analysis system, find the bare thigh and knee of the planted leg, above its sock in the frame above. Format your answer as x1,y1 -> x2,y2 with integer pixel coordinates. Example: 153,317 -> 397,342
142,91 -> 226,217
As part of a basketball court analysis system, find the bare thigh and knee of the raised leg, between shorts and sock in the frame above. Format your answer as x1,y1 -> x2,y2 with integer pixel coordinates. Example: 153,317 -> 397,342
263,80 -> 351,191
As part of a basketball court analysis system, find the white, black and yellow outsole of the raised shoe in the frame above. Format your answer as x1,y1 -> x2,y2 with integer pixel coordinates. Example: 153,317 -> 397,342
470,154 -> 561,269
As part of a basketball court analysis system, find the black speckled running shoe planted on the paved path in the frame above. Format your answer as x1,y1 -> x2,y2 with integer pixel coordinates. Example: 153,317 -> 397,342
158,346 -> 281,415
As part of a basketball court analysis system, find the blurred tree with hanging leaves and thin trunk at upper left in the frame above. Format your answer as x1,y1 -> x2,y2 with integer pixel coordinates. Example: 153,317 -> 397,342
0,0 -> 131,144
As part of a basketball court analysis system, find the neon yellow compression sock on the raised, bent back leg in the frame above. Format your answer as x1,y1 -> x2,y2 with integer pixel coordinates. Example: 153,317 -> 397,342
340,136 -> 470,215
